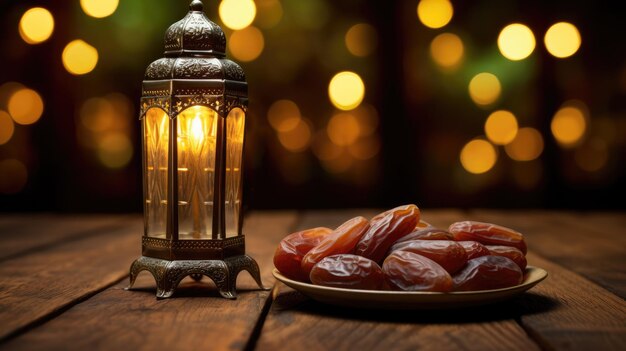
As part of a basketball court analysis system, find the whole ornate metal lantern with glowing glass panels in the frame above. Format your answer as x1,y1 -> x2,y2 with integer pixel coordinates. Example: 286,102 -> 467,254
129,0 -> 263,298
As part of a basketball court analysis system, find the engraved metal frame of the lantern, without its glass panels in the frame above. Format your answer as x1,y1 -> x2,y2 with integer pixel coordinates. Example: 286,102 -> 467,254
127,0 -> 263,299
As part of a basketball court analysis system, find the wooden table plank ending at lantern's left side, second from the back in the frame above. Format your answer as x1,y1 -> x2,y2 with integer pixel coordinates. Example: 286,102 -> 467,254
0,217 -> 143,340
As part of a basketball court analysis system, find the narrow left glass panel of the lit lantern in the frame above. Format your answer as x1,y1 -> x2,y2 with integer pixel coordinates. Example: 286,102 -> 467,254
143,107 -> 170,238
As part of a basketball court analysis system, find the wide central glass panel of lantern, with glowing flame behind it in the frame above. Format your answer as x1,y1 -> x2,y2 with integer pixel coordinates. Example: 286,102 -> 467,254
177,106 -> 219,239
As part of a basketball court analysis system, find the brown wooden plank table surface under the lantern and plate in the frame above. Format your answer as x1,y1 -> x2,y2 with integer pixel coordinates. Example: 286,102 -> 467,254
0,210 -> 626,351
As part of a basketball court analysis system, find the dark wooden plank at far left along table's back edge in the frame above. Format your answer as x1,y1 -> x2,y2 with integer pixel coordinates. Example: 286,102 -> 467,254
0,214 -> 127,261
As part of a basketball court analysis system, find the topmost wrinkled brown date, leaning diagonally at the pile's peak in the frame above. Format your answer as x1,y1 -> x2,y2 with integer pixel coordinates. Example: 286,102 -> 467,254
355,205 -> 420,263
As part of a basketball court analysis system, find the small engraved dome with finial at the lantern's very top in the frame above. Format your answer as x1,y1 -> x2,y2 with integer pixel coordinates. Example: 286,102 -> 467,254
165,0 -> 226,57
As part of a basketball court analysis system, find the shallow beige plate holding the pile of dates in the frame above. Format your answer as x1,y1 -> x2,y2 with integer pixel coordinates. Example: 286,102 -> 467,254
272,266 -> 548,309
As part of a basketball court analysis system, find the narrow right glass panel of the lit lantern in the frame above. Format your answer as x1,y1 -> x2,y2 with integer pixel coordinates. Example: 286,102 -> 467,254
225,108 -> 245,237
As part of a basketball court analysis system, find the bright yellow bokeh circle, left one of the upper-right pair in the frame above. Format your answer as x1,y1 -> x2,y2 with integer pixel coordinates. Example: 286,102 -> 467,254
498,23 -> 535,61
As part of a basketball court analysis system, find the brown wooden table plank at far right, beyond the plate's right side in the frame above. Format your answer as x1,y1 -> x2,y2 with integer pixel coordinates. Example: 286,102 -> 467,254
470,210 -> 626,298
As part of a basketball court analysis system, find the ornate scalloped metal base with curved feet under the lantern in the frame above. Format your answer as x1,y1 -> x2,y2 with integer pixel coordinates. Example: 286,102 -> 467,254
126,255 -> 266,299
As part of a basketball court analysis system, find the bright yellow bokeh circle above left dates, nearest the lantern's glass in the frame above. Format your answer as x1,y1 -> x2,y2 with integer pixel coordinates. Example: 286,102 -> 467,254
328,71 -> 365,111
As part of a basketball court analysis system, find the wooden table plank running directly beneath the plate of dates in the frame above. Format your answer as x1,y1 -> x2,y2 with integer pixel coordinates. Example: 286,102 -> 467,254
256,210 -> 538,350
